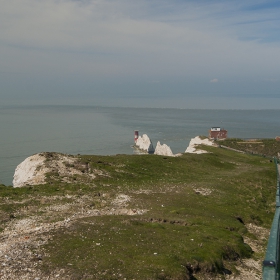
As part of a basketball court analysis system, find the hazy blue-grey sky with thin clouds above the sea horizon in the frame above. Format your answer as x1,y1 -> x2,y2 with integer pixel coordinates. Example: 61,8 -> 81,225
0,0 -> 280,109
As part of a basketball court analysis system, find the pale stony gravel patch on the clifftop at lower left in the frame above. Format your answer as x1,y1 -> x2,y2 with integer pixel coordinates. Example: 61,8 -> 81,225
0,191 -> 146,280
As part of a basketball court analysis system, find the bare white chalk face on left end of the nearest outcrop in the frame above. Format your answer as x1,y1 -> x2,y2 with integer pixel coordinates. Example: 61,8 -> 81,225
13,154 -> 46,188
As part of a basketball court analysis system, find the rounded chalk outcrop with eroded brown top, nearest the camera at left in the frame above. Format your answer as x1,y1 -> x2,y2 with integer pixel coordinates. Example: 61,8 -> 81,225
13,152 -> 95,188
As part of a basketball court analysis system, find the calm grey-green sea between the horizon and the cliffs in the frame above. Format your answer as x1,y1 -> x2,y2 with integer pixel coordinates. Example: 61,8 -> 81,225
0,106 -> 280,185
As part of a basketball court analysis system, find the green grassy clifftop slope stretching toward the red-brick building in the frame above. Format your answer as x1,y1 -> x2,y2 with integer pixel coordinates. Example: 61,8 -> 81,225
0,147 -> 276,279
